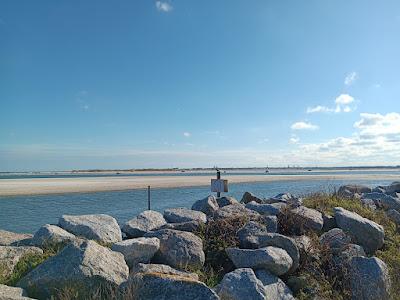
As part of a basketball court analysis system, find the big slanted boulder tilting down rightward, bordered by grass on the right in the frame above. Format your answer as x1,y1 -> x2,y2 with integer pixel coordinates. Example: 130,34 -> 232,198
334,207 -> 385,253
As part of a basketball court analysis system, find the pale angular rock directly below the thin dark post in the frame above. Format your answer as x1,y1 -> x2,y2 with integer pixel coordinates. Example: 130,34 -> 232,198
122,210 -> 167,238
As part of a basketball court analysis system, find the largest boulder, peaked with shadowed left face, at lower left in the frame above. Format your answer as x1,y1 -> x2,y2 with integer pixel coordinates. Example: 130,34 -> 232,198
18,240 -> 129,299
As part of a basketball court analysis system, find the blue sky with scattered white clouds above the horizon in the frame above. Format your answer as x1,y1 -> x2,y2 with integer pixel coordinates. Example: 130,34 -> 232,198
0,0 -> 400,171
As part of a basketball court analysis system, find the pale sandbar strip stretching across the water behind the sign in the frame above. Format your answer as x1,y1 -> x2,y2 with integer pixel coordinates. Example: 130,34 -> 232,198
0,174 -> 399,196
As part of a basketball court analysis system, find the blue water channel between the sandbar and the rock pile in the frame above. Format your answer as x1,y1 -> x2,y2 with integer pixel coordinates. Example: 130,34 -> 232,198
0,179 -> 391,233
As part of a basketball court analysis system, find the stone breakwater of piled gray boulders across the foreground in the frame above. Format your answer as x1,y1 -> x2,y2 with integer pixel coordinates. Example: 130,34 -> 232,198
0,182 -> 400,300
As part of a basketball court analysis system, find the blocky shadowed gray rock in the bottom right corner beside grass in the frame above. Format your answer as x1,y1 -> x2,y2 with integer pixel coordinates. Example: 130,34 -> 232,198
349,257 -> 390,300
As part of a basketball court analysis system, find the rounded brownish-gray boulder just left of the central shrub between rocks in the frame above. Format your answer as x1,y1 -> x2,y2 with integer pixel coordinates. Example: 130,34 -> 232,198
145,229 -> 205,270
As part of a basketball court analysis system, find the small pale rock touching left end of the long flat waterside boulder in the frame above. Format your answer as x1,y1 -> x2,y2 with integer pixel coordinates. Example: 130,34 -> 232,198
31,224 -> 75,247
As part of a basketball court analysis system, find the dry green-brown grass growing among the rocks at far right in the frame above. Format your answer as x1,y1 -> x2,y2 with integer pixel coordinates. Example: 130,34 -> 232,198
304,194 -> 400,300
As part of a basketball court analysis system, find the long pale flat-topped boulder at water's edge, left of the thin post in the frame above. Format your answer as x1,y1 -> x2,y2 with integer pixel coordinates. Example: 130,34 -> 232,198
58,214 -> 122,243
